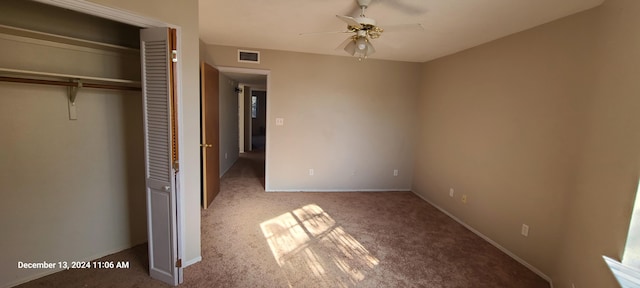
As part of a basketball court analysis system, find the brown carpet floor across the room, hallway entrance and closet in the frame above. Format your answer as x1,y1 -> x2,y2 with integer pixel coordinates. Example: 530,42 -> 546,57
20,153 -> 549,288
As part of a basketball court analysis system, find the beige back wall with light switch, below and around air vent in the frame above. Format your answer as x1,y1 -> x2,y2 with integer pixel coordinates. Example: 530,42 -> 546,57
207,45 -> 420,191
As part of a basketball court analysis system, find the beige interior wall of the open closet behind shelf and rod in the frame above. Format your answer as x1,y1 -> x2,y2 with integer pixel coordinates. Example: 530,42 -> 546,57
0,0 -> 147,287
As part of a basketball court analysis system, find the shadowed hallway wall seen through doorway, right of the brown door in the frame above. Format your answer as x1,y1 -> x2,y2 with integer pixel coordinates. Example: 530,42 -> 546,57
219,74 -> 240,177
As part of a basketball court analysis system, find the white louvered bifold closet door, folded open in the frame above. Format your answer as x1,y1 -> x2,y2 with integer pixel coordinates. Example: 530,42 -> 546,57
140,28 -> 182,285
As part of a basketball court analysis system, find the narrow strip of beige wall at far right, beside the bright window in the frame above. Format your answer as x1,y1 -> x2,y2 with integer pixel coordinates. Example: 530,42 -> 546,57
556,0 -> 640,287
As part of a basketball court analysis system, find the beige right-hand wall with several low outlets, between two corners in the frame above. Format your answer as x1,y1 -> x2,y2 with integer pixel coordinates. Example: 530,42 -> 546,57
414,6 -> 591,273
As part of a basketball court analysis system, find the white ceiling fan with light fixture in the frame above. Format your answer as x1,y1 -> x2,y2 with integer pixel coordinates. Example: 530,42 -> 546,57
301,0 -> 424,60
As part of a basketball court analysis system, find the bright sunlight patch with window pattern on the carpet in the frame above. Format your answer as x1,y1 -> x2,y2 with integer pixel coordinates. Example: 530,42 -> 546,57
260,204 -> 380,287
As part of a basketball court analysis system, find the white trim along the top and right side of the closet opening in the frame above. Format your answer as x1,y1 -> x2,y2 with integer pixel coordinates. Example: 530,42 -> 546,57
35,0 -> 186,282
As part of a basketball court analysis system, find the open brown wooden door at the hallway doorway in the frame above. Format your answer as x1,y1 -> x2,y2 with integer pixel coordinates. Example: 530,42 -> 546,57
200,62 -> 220,209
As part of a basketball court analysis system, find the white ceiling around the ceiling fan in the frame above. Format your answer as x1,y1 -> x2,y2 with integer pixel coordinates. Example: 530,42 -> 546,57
199,0 -> 604,62
